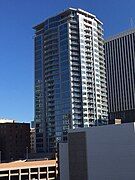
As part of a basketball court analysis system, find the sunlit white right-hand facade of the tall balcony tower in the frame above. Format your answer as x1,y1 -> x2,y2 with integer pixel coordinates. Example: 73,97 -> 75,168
69,9 -> 107,128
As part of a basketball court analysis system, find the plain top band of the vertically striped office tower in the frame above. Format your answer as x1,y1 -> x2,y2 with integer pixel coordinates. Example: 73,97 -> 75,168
105,28 -> 135,43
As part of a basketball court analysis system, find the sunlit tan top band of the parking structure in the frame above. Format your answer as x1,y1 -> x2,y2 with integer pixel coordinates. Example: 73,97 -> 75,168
0,160 -> 56,171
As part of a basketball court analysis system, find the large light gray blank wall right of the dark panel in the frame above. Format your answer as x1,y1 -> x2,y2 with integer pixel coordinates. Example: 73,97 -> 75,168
86,123 -> 135,180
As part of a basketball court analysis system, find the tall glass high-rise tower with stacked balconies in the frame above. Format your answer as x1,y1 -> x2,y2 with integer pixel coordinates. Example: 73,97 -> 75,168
34,8 -> 107,152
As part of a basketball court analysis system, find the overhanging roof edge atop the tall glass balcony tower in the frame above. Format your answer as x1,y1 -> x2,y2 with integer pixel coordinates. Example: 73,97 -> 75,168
33,7 -> 103,30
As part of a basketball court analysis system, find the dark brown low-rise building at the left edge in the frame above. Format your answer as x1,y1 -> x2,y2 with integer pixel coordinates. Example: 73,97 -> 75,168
0,120 -> 30,162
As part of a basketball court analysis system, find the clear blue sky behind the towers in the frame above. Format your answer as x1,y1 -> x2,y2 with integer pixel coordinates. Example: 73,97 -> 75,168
0,0 -> 135,122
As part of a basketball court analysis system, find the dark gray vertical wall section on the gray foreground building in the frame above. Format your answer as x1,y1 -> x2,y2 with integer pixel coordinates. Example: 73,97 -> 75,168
68,132 -> 88,180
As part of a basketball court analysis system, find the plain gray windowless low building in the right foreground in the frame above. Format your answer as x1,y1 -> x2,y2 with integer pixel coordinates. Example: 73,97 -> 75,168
59,123 -> 135,180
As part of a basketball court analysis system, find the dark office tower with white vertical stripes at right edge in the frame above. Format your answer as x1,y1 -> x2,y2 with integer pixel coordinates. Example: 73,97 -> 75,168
105,29 -> 135,122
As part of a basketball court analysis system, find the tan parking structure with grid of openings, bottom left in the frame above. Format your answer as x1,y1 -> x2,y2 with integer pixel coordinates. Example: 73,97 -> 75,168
0,159 -> 57,180
